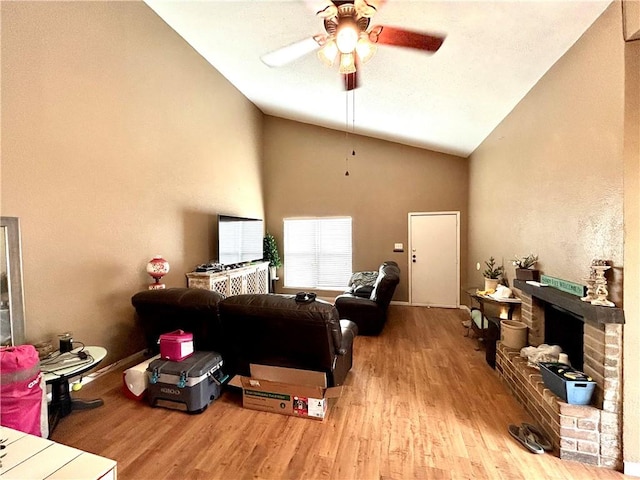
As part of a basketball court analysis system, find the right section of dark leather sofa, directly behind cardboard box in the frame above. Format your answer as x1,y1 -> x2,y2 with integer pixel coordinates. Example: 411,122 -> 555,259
218,294 -> 358,386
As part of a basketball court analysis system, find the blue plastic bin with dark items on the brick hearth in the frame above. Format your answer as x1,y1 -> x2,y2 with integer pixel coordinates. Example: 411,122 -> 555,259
538,362 -> 596,405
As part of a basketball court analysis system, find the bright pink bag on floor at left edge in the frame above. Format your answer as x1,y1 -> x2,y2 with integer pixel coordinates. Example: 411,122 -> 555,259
0,345 -> 49,437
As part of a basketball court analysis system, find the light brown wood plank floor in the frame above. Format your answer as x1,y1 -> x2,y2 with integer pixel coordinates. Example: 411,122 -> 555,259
52,306 -> 630,480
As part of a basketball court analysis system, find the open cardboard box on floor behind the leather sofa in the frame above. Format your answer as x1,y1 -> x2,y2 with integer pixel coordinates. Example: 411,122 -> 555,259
229,364 -> 342,420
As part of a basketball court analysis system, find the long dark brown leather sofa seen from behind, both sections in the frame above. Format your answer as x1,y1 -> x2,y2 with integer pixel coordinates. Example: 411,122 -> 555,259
131,288 -> 358,386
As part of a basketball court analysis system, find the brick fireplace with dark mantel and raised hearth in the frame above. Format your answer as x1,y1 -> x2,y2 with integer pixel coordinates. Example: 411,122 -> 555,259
496,280 -> 624,470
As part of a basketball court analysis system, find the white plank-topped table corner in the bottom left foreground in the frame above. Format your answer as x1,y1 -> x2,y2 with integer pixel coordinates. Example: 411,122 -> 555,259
0,427 -> 118,480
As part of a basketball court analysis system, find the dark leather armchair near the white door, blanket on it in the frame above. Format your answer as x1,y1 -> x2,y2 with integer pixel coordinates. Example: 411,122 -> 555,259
335,261 -> 400,335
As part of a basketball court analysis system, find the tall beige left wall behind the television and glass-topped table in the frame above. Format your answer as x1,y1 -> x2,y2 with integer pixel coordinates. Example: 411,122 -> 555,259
1,2 -> 264,362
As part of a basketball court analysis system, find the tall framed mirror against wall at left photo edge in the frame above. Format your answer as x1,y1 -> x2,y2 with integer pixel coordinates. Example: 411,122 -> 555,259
0,217 -> 26,346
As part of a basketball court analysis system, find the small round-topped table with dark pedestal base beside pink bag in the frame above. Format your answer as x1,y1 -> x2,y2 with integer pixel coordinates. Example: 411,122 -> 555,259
40,346 -> 107,432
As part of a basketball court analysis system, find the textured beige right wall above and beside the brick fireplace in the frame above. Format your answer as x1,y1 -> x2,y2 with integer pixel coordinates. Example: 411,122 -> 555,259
469,2 -> 640,468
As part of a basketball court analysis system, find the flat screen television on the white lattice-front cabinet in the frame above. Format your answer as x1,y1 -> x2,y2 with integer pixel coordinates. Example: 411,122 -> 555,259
218,215 -> 264,265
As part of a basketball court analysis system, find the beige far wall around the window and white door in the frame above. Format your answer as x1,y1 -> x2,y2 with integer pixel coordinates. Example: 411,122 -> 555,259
264,116 -> 469,301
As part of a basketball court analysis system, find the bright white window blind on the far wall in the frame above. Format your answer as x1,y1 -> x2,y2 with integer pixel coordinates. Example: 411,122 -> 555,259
284,217 -> 352,290
